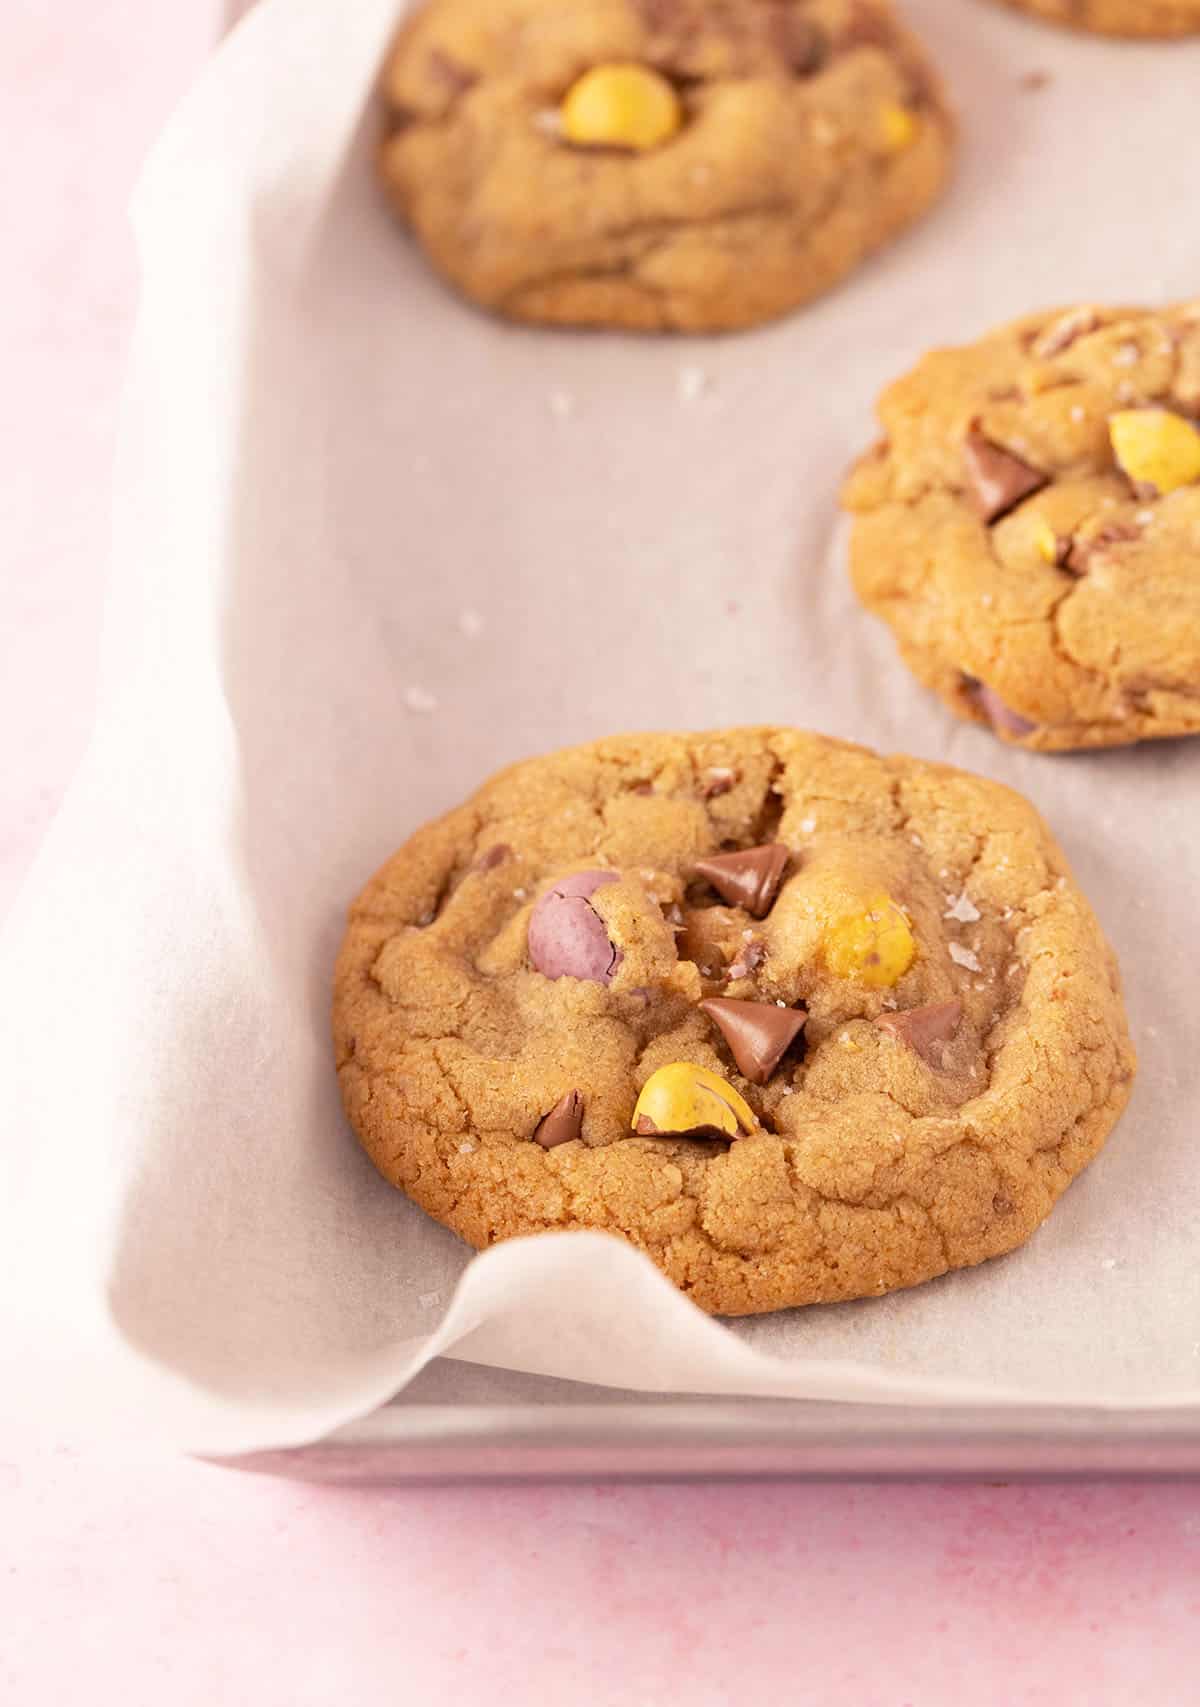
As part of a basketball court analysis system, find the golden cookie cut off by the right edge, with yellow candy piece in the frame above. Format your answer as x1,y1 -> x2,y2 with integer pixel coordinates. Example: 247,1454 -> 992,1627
843,302 -> 1200,751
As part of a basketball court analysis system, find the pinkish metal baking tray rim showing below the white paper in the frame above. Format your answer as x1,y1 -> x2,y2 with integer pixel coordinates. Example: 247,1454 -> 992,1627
201,0 -> 1200,1485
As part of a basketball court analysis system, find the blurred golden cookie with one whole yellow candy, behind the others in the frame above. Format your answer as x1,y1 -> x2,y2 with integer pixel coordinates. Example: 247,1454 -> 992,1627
381,0 -> 952,331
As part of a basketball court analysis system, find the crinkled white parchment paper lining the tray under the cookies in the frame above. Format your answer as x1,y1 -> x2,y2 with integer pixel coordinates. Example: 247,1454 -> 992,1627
0,0 -> 1200,1451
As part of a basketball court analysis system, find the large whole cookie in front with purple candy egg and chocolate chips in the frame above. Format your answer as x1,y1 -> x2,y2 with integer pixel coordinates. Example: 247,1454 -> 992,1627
335,729 -> 1133,1314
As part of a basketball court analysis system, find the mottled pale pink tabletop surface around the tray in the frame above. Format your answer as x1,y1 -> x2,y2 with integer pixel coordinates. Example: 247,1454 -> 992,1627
0,0 -> 1200,1707
